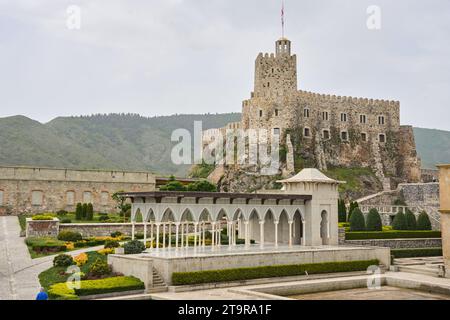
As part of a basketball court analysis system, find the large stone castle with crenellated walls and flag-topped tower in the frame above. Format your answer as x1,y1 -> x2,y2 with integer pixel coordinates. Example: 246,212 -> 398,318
205,38 -> 421,190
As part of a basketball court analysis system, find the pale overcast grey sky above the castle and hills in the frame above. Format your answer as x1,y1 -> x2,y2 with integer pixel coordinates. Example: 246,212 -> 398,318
0,0 -> 450,130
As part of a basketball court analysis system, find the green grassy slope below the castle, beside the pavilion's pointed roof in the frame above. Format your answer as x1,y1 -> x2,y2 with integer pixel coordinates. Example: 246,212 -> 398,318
324,167 -> 376,193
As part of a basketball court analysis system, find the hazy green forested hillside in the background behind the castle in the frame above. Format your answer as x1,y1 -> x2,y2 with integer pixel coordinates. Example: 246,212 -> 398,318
0,113 -> 450,176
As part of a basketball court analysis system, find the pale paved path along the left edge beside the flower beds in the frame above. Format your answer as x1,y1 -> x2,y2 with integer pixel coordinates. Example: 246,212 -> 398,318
0,216 -> 103,300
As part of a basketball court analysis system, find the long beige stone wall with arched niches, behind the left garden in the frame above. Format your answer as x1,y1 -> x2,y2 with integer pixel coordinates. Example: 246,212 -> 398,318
0,167 -> 155,214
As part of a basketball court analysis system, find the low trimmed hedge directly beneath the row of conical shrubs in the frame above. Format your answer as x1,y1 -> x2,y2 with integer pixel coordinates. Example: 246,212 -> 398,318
345,230 -> 441,240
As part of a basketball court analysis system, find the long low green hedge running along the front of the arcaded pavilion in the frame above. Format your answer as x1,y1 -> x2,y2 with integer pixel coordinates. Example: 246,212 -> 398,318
172,260 -> 379,285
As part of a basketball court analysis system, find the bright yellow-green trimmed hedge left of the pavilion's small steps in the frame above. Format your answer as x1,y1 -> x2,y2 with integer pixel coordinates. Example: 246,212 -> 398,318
48,277 -> 145,300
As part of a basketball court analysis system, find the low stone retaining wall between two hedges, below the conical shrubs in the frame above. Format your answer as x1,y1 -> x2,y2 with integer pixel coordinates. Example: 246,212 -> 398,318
345,239 -> 442,249
